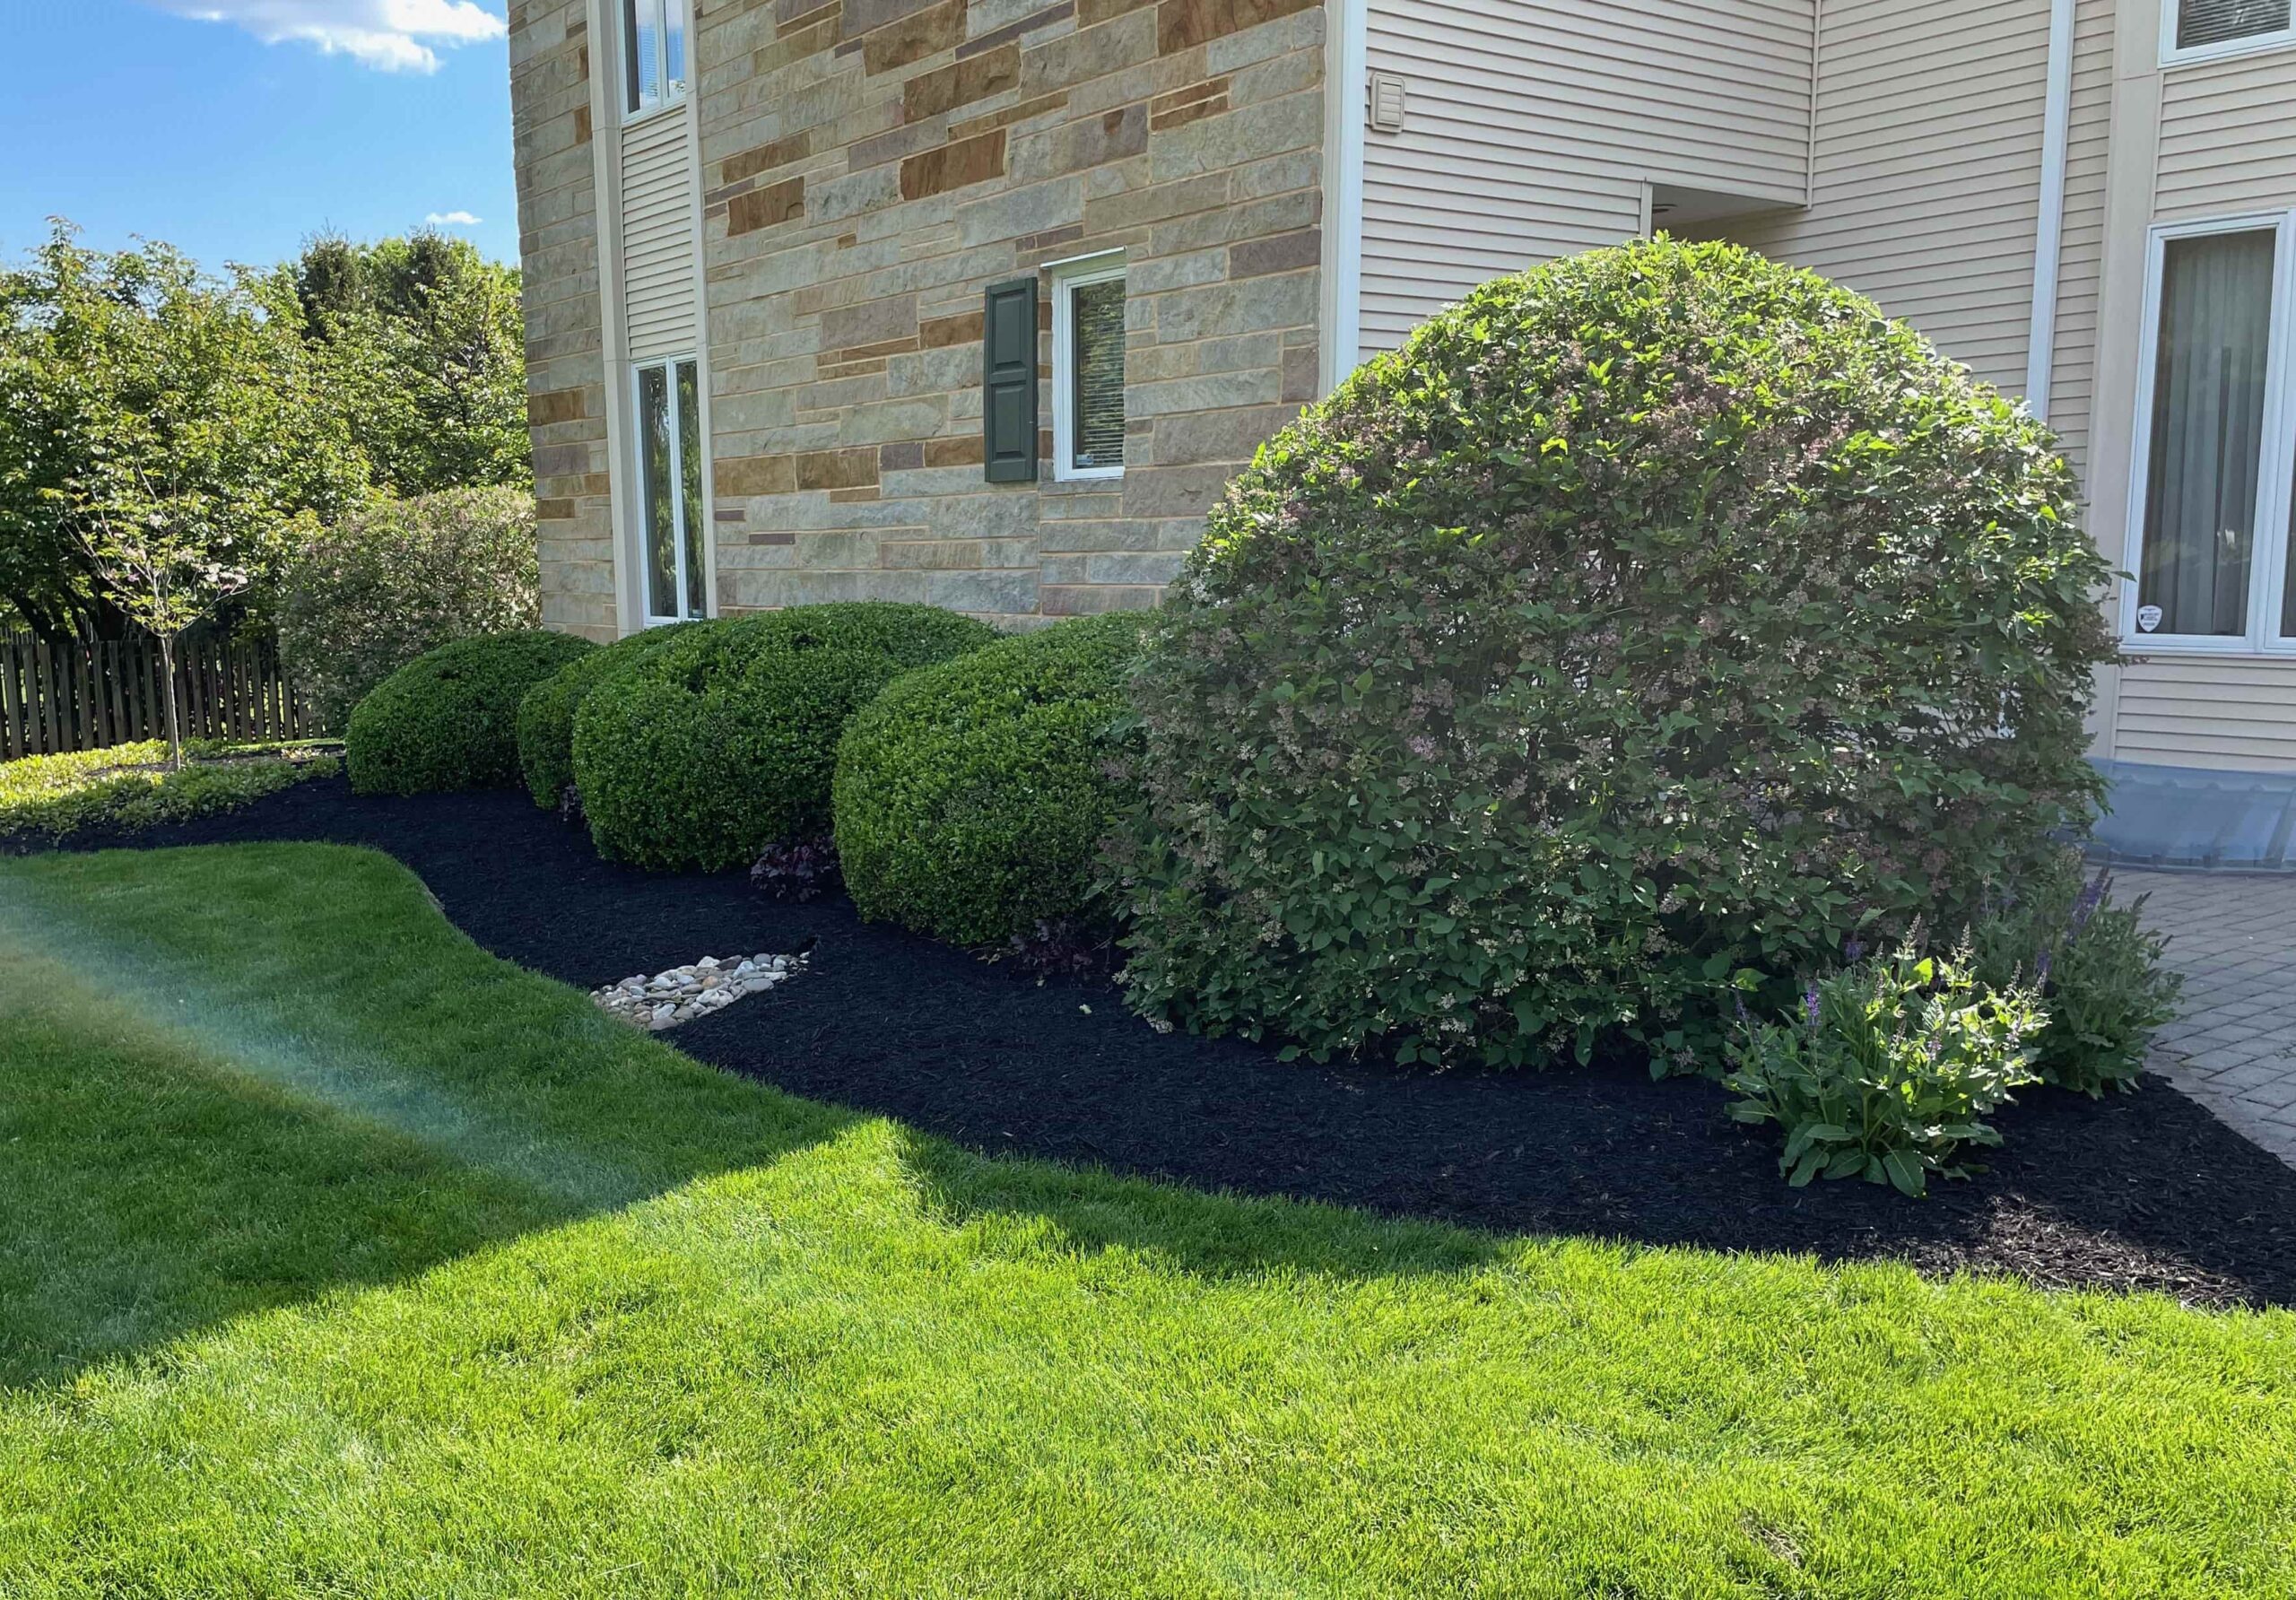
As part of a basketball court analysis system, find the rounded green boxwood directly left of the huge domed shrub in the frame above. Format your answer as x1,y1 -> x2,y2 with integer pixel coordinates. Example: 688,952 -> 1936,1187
836,613 -> 1145,946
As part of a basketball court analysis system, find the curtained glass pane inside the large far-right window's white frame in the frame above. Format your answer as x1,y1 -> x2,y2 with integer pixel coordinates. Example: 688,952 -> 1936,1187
2137,230 -> 2275,639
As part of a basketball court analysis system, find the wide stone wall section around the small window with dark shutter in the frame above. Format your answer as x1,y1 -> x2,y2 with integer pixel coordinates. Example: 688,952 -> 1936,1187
693,0 -> 1325,622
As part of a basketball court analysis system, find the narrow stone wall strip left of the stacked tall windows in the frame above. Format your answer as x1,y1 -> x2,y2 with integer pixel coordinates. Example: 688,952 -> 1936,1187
509,0 -> 618,639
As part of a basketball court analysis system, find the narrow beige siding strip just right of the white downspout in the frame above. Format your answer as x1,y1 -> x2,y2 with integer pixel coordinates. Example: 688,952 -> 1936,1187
2048,0 -> 2115,493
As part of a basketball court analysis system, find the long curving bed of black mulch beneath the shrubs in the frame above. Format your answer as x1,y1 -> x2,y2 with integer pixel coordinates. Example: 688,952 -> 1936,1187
27,778 -> 2296,1304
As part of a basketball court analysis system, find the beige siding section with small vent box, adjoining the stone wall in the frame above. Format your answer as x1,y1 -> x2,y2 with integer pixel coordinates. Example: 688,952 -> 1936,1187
1361,0 -> 1812,353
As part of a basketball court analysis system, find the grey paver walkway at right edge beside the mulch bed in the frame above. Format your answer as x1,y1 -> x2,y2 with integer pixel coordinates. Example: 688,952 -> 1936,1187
2112,868 -> 2296,1166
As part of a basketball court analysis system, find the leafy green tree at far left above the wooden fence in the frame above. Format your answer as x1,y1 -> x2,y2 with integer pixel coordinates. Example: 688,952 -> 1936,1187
0,222 -> 365,633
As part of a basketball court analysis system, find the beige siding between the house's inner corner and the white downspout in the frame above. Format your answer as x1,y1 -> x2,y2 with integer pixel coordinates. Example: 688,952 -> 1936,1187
1706,0 -> 2048,388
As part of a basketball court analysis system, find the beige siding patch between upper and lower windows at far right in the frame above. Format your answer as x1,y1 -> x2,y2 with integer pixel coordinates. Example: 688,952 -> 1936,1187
2153,50 -> 2296,222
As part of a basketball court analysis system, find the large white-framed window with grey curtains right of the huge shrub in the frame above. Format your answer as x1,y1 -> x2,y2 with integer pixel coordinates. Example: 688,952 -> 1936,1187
2121,213 -> 2296,654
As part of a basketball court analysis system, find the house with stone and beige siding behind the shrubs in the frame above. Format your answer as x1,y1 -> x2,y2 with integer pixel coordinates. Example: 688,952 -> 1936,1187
509,0 -> 2296,854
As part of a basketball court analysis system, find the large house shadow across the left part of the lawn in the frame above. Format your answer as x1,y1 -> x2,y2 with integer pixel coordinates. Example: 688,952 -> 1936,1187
0,847 -> 854,1387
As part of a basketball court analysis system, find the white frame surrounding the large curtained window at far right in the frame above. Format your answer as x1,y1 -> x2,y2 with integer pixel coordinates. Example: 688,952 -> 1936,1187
2119,211 -> 2296,657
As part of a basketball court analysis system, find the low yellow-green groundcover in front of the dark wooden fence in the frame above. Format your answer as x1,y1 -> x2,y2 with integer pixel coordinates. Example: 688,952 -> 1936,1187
0,739 -> 342,845
